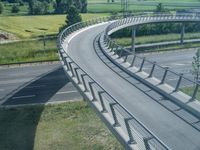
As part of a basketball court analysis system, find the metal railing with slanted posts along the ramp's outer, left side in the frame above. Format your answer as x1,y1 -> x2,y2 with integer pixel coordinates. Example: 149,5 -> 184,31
57,14 -> 170,150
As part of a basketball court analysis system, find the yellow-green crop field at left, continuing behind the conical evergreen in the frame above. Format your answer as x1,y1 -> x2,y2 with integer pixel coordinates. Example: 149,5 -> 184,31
0,13 -> 109,38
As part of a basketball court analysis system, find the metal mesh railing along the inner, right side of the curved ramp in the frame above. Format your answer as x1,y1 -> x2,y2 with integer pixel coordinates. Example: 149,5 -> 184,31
102,14 -> 200,101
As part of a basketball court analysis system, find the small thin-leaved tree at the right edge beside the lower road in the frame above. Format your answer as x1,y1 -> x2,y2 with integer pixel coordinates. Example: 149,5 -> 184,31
191,48 -> 200,81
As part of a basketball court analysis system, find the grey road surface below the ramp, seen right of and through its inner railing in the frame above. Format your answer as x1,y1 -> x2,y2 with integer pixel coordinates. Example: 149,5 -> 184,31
128,49 -> 196,87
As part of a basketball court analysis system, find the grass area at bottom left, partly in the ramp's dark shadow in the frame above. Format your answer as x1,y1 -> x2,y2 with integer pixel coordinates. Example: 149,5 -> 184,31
0,101 -> 123,150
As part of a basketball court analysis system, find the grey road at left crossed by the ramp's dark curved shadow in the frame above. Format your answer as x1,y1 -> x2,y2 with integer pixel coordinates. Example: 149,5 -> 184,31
0,64 -> 82,105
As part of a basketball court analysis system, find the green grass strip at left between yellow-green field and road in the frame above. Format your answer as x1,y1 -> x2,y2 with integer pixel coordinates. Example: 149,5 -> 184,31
0,39 -> 58,64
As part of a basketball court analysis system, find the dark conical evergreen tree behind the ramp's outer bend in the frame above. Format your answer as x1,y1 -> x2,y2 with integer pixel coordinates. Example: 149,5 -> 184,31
65,5 -> 82,26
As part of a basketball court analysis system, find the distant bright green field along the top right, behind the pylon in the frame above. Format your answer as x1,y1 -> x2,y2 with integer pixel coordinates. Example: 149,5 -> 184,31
88,0 -> 200,12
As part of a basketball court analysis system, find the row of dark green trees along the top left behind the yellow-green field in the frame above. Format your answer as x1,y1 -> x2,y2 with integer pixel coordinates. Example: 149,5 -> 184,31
0,0 -> 87,15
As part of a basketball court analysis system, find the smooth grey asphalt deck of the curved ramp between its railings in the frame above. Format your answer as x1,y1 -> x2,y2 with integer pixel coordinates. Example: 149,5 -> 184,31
64,24 -> 200,150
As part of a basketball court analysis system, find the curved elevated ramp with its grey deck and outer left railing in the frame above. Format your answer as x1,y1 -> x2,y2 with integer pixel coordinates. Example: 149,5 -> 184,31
58,13 -> 200,150
